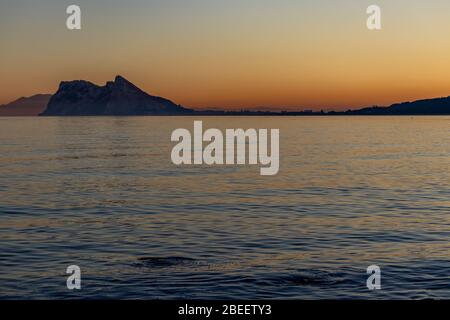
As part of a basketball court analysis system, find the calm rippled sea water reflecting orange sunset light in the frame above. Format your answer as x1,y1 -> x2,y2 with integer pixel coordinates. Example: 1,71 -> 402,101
0,117 -> 450,299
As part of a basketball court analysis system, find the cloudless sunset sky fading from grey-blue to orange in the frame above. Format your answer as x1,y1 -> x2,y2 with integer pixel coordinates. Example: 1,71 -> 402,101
0,0 -> 450,110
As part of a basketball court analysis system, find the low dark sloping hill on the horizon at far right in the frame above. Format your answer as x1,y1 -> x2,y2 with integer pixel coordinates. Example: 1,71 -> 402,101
346,97 -> 450,115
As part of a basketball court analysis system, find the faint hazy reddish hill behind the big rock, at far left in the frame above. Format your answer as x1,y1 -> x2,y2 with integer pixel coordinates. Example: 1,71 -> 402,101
0,94 -> 52,117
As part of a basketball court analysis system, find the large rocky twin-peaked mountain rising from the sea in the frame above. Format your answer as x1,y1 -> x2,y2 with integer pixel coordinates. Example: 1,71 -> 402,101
41,76 -> 192,116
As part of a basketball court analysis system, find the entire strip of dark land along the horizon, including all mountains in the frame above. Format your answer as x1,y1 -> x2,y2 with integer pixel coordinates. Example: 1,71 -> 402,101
0,76 -> 450,117
